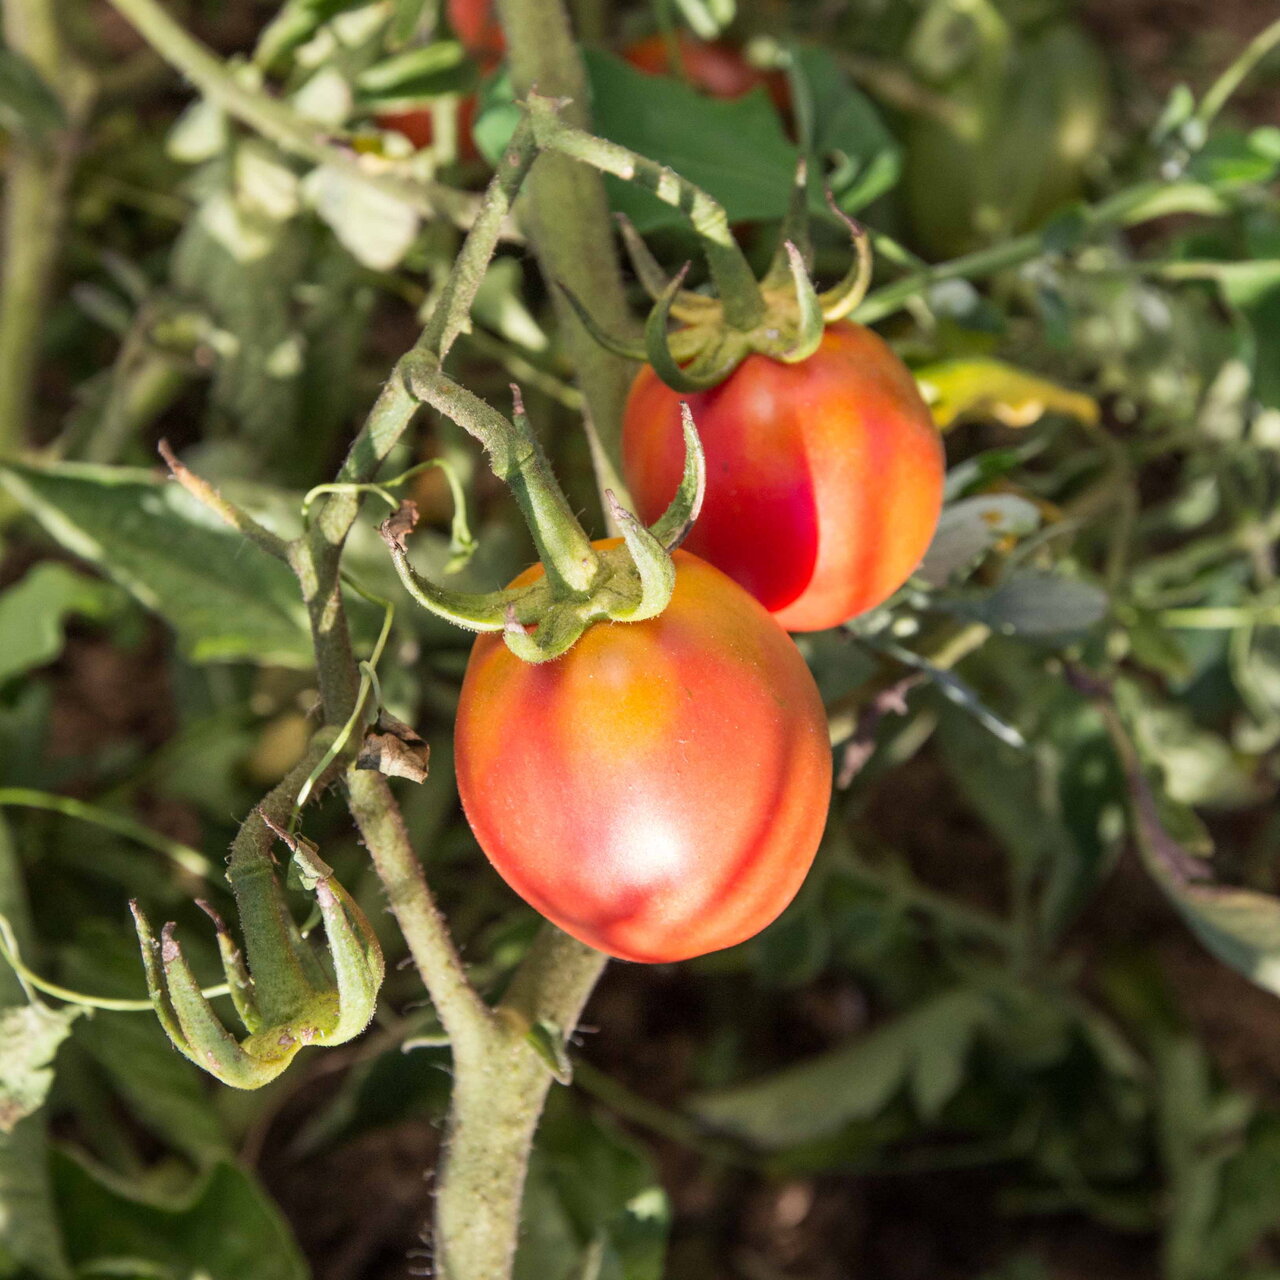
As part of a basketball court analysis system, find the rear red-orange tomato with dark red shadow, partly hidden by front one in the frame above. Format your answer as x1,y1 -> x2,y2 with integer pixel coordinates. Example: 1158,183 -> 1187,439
622,321 -> 943,631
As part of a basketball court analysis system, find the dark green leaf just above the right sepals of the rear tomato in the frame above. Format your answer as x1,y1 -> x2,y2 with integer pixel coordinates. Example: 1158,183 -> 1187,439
791,45 -> 902,214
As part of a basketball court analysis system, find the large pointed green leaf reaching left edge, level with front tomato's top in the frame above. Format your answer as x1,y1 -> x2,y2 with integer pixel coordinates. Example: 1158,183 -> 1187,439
0,463 -> 314,669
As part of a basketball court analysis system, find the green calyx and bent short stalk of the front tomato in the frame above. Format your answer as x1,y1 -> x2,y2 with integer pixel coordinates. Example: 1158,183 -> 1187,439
379,361 -> 707,663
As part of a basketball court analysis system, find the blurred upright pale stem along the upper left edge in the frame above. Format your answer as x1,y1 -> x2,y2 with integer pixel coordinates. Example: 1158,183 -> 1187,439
0,0 -> 92,458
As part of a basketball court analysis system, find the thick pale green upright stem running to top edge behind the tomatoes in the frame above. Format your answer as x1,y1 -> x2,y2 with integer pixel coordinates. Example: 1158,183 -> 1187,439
498,0 -> 634,462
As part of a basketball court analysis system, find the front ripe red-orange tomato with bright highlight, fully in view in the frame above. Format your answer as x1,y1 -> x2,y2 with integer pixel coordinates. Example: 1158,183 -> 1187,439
456,541 -> 831,964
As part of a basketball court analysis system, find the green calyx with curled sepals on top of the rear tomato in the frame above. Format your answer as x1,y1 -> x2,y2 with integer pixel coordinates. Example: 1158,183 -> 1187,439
561,161 -> 872,393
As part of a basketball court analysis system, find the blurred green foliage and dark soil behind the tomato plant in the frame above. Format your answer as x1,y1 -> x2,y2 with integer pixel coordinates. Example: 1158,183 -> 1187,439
0,0 -> 1280,1280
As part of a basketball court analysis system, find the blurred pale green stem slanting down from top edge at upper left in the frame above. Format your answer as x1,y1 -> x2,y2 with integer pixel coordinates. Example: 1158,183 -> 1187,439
103,0 -> 476,227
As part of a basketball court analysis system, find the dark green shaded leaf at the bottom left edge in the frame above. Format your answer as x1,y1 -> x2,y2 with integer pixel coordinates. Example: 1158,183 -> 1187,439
52,1152 -> 307,1280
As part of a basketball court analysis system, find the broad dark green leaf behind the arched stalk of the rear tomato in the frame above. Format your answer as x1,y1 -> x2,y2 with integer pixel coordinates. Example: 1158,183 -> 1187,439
585,49 -> 796,232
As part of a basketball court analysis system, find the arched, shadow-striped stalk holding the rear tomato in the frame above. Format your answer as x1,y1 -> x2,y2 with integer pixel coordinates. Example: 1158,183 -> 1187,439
529,93 -> 765,332
